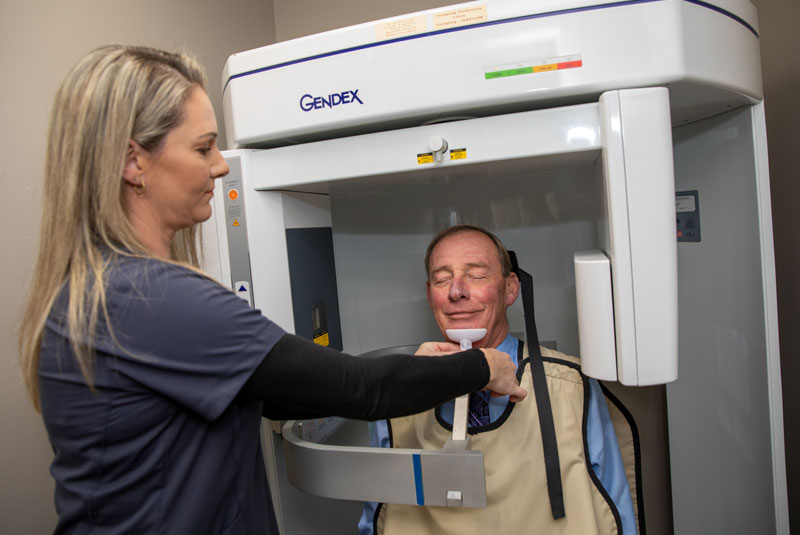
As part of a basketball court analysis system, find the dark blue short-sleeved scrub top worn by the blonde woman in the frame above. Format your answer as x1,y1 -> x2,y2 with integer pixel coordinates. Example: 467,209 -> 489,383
39,258 -> 284,535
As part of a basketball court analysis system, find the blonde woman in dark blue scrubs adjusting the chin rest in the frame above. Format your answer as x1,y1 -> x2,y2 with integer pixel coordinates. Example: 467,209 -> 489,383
20,46 -> 526,534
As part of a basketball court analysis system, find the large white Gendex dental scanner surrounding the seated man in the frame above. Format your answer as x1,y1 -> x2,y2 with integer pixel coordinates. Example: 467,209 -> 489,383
200,0 -> 789,535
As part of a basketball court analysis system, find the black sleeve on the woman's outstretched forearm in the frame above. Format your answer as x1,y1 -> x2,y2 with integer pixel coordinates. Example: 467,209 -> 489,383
241,334 -> 489,420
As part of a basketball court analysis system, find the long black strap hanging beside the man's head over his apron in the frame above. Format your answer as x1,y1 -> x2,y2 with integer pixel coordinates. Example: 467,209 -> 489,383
508,251 -> 566,519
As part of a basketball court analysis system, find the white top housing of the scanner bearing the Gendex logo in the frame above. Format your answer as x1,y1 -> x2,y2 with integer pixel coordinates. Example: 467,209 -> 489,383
222,0 -> 762,148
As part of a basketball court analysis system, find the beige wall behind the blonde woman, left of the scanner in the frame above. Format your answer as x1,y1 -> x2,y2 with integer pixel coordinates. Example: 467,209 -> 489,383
0,0 -> 275,534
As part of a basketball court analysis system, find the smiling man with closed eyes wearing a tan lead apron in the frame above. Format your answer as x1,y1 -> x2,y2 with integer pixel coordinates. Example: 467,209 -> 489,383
359,225 -> 637,535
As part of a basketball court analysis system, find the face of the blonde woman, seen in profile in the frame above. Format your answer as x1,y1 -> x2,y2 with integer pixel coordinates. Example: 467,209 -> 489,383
141,88 -> 229,233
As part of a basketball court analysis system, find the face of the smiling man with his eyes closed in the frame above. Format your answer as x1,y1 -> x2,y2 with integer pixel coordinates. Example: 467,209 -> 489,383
427,231 -> 519,347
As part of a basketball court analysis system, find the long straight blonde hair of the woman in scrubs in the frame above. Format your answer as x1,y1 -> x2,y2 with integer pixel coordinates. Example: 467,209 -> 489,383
19,45 -> 206,410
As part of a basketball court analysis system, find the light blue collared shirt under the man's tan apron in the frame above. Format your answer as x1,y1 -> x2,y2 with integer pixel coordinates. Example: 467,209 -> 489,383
358,334 -> 636,535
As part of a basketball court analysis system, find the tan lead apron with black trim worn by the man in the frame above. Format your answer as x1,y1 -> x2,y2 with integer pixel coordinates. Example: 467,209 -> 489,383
376,348 -> 637,535
